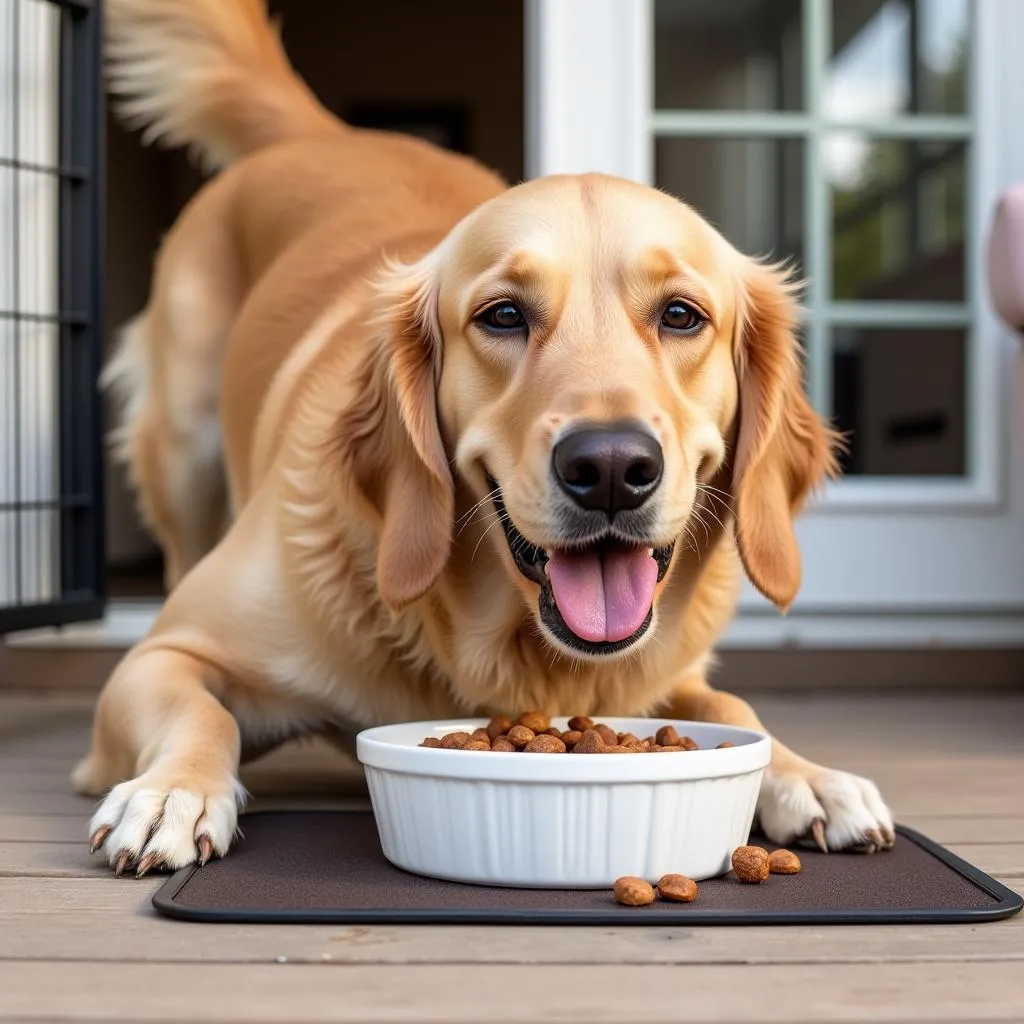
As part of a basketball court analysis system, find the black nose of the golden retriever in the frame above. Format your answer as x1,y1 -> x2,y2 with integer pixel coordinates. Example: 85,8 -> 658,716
553,426 -> 665,516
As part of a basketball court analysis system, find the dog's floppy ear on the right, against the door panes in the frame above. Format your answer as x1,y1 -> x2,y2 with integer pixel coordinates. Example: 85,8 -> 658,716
732,260 -> 839,610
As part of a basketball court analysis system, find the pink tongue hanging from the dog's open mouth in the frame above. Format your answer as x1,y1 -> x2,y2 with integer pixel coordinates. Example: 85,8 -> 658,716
548,548 -> 657,643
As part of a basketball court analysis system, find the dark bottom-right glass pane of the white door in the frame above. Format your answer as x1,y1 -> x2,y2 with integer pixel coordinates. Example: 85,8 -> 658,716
833,328 -> 966,476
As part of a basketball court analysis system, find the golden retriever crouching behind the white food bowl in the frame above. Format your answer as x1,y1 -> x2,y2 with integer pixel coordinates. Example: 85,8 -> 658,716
74,0 -> 893,874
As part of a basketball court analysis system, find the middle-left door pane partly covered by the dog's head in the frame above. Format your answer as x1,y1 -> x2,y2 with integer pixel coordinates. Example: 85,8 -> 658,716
654,138 -> 804,263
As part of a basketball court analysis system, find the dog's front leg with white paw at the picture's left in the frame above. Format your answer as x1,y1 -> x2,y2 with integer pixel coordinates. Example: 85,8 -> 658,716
72,647 -> 244,874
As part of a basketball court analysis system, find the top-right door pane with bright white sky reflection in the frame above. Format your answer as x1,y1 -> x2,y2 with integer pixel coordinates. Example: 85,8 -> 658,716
824,0 -> 971,118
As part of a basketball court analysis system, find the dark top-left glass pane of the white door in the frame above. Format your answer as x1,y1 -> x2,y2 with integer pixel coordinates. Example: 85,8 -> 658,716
651,0 -> 804,111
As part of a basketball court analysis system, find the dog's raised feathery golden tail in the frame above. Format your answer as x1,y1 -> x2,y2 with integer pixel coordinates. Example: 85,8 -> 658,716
106,0 -> 344,168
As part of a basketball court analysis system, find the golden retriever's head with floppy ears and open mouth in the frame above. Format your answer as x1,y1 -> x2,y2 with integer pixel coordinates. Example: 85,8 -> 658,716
378,175 -> 834,657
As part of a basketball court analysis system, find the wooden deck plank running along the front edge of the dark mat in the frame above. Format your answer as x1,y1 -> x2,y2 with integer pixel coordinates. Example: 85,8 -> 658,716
0,878 -> 1024,973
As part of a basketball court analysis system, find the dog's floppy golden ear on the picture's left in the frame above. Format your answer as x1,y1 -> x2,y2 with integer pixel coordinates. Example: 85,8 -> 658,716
355,255 -> 455,610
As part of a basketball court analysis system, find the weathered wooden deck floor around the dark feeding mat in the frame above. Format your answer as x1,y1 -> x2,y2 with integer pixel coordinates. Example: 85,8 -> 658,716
0,692 -> 1024,1024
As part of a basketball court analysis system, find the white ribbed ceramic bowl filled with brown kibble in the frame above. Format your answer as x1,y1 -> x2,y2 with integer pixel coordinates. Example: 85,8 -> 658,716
356,718 -> 771,889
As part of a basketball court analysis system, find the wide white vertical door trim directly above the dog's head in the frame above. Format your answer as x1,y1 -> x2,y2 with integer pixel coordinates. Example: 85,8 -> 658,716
523,0 -> 653,182
